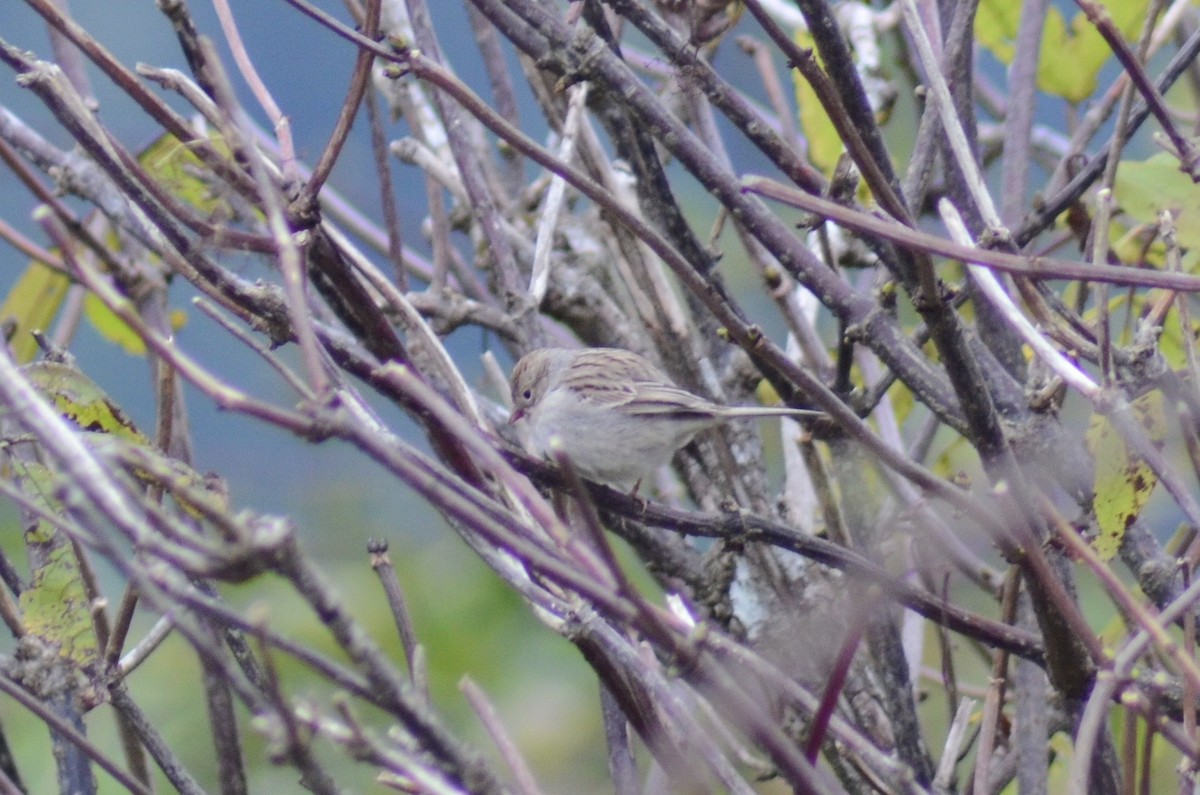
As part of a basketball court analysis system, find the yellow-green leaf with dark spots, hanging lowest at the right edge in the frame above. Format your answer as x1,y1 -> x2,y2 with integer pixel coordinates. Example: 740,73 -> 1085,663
1087,393 -> 1166,561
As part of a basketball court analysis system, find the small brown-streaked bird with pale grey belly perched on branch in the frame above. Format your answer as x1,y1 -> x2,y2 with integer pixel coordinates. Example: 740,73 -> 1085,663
509,348 -> 822,490
